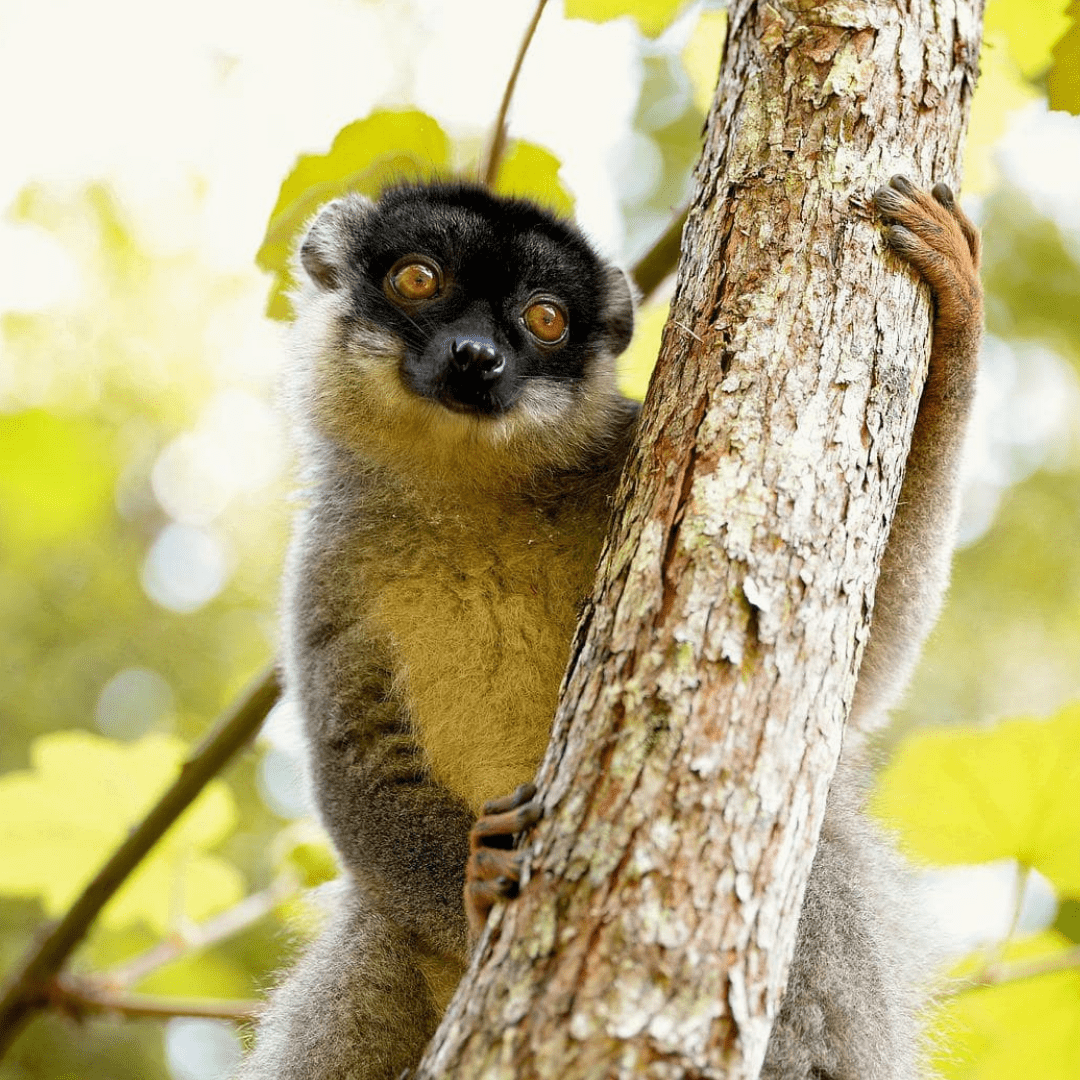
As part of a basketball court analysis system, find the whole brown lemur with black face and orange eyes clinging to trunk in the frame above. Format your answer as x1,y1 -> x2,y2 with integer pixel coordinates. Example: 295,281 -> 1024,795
242,177 -> 982,1080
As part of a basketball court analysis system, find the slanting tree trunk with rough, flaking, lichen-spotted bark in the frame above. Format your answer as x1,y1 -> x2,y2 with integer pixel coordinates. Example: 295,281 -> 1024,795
418,0 -> 982,1080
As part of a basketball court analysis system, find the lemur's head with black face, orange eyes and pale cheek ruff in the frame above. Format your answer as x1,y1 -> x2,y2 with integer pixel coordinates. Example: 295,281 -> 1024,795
294,184 -> 633,479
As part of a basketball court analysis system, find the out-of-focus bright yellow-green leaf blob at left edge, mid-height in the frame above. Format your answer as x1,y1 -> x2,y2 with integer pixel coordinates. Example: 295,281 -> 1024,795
0,409 -> 116,550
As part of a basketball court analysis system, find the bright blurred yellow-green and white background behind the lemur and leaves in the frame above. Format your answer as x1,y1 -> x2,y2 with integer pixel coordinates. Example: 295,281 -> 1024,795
0,0 -> 1080,1080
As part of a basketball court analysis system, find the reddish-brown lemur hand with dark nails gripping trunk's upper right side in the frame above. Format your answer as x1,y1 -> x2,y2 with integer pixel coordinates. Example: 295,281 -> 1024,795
874,176 -> 982,339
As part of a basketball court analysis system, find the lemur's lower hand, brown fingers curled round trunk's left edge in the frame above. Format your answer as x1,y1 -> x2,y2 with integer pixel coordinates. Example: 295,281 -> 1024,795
465,784 -> 542,940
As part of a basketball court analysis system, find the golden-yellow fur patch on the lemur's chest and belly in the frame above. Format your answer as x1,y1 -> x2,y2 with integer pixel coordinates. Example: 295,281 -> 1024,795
375,509 -> 598,811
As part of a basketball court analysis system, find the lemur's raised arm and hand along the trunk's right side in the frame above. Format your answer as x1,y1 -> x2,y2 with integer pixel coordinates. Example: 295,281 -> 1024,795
851,176 -> 983,729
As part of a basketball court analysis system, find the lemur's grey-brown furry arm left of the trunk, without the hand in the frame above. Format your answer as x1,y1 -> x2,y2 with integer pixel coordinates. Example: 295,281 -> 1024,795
287,529 -> 474,958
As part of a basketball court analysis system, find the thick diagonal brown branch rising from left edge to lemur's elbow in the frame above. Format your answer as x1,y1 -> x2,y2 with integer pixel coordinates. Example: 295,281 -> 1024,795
0,669 -> 280,1056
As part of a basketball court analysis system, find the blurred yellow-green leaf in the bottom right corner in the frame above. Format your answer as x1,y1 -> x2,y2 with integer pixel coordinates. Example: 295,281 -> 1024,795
933,932 -> 1080,1080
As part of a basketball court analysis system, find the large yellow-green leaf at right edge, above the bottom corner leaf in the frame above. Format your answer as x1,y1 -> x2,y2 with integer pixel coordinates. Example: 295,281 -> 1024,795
874,705 -> 1080,895
